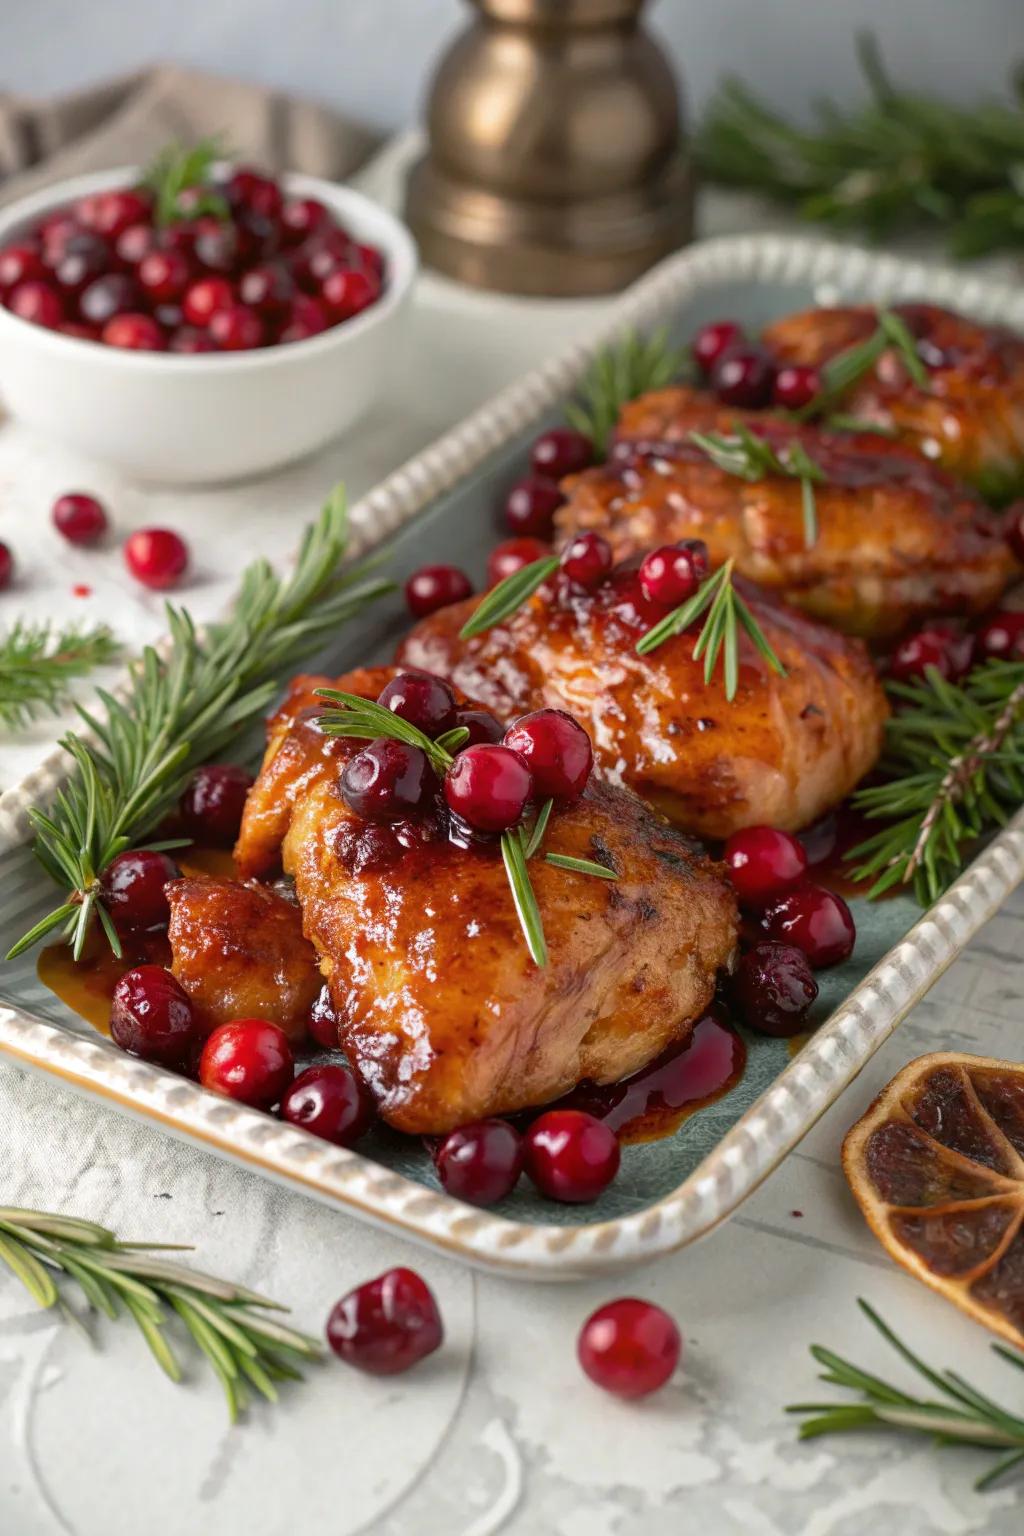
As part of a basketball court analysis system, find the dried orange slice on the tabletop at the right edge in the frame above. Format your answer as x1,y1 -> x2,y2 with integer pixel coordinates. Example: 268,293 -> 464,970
843,1052 -> 1024,1349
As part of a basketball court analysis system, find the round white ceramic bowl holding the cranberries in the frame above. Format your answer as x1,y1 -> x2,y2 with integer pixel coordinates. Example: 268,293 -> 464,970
0,167 -> 416,484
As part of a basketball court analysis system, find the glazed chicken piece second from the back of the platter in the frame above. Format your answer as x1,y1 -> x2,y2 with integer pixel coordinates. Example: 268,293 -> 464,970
568,387 -> 1018,639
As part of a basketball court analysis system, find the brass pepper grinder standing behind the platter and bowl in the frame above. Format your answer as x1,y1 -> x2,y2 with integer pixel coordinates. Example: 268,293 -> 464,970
405,0 -> 692,295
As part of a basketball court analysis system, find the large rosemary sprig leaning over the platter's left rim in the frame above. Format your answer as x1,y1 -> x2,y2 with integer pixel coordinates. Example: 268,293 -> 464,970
8,487 -> 393,958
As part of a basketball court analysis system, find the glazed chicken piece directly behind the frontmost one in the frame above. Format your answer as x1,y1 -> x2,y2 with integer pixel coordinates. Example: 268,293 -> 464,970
398,584 -> 887,837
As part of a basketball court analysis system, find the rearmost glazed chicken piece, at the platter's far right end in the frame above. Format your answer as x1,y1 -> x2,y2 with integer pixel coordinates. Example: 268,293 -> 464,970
763,304 -> 1024,501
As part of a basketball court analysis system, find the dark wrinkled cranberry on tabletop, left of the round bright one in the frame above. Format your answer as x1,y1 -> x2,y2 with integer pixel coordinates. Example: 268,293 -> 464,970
327,1269 -> 444,1376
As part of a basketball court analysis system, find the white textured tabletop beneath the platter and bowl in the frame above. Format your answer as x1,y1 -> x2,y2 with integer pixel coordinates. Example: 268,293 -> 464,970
0,138 -> 1024,1536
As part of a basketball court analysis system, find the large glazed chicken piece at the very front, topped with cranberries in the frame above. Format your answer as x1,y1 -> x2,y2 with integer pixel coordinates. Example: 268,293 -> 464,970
236,670 -> 737,1134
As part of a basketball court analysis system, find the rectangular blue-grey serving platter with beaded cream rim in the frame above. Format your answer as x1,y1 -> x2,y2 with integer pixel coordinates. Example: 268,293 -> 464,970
0,237 -> 1024,1279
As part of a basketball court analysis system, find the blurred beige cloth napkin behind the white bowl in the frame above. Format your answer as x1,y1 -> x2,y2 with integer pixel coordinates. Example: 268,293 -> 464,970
0,65 -> 379,204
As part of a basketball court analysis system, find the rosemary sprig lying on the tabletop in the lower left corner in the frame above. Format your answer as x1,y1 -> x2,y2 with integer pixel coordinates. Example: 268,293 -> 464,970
0,1207 -> 321,1422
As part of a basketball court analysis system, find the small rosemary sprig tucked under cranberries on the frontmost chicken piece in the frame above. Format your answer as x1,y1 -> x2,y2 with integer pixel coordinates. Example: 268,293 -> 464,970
316,688 -> 617,966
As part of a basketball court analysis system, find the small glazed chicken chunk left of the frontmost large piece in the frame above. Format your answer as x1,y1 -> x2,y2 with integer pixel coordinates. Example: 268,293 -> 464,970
167,877 -> 322,1040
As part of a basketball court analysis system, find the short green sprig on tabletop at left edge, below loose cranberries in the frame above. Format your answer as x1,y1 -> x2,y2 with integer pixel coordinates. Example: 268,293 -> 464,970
0,622 -> 118,730
